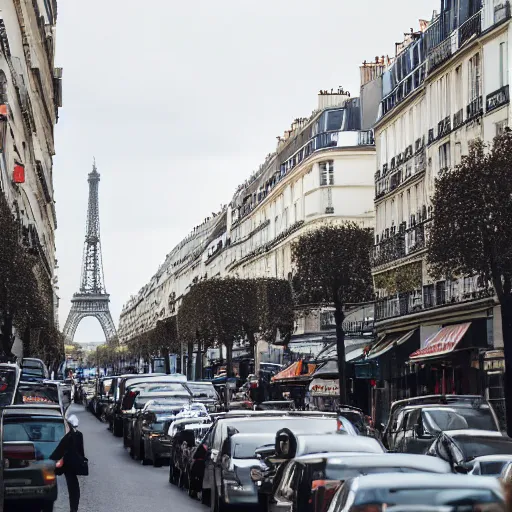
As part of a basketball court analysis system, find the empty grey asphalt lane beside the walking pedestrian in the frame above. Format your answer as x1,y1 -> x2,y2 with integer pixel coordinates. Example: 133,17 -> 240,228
50,405 -> 204,512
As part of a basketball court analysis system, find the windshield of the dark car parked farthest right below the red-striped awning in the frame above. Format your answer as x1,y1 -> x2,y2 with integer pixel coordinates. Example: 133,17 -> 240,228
423,406 -> 498,431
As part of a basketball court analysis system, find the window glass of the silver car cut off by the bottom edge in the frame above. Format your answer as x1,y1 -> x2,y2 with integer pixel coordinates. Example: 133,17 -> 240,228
355,488 -> 501,507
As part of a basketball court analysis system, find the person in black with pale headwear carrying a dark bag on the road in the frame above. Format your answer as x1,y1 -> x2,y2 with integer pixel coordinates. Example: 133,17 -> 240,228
50,414 -> 88,512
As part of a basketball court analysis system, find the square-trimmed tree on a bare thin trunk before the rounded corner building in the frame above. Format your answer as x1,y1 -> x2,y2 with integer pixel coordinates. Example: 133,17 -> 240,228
292,222 -> 373,403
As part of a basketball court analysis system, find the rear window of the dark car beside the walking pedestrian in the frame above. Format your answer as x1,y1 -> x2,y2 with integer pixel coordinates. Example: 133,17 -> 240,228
4,417 -> 65,459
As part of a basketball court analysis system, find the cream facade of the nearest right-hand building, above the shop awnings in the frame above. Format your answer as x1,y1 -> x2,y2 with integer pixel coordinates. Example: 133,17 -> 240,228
373,0 -> 512,346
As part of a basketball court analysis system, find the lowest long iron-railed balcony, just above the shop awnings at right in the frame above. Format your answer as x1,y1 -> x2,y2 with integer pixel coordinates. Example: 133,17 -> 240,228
375,278 -> 494,322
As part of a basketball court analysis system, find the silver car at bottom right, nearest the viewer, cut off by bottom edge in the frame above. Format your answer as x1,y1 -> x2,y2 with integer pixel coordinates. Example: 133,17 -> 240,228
329,473 -> 503,512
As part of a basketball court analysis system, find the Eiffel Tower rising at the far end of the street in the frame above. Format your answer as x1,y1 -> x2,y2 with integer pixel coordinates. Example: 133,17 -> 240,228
64,161 -> 116,342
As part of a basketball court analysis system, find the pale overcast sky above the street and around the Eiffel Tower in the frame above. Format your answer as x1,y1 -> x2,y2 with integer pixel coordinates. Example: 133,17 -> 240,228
54,0 -> 440,342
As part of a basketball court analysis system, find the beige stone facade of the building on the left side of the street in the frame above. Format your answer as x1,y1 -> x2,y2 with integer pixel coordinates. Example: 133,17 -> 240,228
0,0 -> 62,344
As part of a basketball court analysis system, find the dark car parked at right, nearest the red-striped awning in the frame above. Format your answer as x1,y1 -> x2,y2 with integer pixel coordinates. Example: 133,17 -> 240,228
383,395 -> 500,453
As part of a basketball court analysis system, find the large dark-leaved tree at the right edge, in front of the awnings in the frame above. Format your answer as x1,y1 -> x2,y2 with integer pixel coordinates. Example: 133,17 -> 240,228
428,132 -> 512,435
